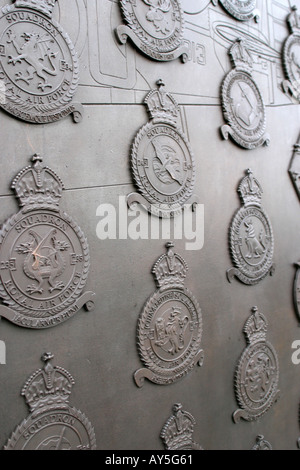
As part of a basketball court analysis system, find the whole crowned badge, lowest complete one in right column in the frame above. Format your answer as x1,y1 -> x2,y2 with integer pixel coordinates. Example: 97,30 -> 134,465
233,307 -> 280,423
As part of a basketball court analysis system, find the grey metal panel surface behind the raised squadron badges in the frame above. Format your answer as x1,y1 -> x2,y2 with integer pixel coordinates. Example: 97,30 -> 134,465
0,0 -> 300,450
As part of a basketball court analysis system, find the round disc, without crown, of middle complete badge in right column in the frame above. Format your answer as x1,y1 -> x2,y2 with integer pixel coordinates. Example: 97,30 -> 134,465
230,206 -> 274,285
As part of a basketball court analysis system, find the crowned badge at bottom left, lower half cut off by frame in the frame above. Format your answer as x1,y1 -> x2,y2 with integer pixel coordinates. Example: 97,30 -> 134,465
4,353 -> 96,450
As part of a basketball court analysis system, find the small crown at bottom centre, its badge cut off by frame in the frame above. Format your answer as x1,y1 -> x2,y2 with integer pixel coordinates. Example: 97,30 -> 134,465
160,403 -> 203,450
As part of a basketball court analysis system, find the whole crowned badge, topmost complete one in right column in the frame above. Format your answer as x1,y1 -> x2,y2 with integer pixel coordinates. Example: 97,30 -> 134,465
221,39 -> 270,149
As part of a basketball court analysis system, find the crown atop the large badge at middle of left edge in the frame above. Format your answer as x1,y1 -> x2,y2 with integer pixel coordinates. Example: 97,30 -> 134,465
11,154 -> 64,212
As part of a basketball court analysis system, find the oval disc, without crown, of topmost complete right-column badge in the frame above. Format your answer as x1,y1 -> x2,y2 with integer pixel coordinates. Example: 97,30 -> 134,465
222,70 -> 266,149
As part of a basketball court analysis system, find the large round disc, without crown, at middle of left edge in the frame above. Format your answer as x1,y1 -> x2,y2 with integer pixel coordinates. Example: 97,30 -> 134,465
0,210 -> 89,328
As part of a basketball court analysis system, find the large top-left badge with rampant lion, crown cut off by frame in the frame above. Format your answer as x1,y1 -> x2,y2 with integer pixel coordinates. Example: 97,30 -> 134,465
0,0 -> 83,124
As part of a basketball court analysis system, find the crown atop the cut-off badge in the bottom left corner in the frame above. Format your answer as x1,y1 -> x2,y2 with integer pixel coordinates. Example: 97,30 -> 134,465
21,353 -> 75,412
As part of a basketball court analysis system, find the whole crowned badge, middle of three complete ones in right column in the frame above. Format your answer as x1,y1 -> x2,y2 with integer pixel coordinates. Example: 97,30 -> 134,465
227,169 -> 275,285
